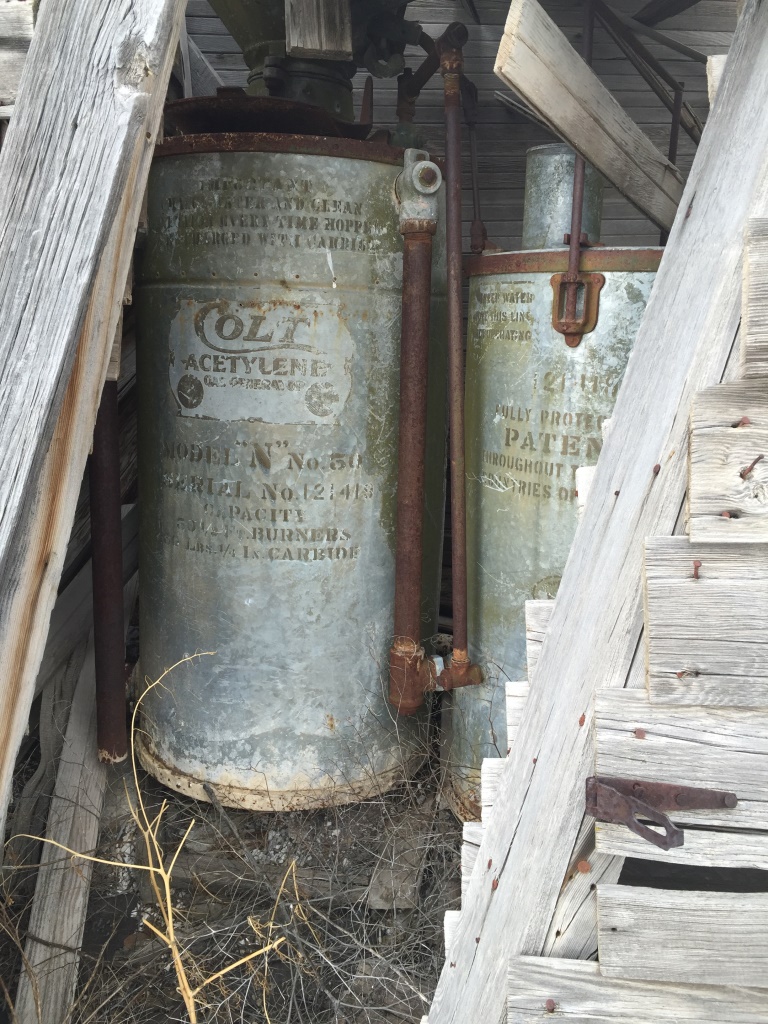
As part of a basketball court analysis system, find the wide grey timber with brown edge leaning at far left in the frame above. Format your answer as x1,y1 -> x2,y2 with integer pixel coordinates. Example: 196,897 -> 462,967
0,0 -> 183,843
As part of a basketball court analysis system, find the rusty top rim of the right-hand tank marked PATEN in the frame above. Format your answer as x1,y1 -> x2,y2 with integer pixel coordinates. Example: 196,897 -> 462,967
464,248 -> 664,278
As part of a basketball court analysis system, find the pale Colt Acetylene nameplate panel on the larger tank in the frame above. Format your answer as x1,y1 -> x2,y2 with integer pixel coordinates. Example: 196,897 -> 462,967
169,296 -> 354,424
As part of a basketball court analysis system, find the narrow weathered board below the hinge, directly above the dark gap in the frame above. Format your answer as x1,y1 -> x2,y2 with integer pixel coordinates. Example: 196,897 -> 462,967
595,821 -> 768,868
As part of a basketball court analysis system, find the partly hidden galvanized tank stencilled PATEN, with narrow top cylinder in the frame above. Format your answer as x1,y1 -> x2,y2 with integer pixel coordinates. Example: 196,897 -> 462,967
443,144 -> 662,818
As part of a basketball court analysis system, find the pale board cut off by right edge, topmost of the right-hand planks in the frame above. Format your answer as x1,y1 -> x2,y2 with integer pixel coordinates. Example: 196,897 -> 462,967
741,217 -> 768,378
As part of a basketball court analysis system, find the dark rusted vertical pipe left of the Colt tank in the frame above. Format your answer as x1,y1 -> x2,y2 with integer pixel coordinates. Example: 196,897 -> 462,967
88,381 -> 128,763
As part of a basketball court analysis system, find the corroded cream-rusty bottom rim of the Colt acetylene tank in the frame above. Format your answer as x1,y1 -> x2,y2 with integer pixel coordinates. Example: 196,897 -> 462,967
135,737 -> 425,812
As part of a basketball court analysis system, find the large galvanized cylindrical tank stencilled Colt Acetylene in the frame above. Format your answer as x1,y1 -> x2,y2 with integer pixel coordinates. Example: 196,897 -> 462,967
137,134 -> 445,811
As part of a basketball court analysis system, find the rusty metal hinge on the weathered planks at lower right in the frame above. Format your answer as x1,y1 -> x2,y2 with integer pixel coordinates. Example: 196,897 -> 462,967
587,775 -> 737,850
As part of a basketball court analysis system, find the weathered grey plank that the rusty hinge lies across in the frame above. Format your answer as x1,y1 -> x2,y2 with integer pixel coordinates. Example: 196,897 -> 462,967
595,690 -> 768,830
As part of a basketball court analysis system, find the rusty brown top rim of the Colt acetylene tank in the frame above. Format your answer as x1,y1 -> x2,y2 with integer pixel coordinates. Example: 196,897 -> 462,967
155,132 -> 404,166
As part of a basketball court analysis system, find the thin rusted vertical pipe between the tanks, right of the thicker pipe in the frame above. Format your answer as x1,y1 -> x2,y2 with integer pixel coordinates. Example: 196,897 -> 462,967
437,23 -> 469,666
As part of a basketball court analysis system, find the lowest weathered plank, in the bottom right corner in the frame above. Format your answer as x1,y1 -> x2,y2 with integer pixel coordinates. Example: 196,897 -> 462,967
507,956 -> 765,1024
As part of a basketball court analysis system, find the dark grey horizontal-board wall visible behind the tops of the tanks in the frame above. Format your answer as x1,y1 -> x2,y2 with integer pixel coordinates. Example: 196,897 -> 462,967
186,0 -> 736,249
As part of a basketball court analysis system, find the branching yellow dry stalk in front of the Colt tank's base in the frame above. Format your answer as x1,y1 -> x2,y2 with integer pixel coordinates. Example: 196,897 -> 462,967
7,650 -> 286,1024
